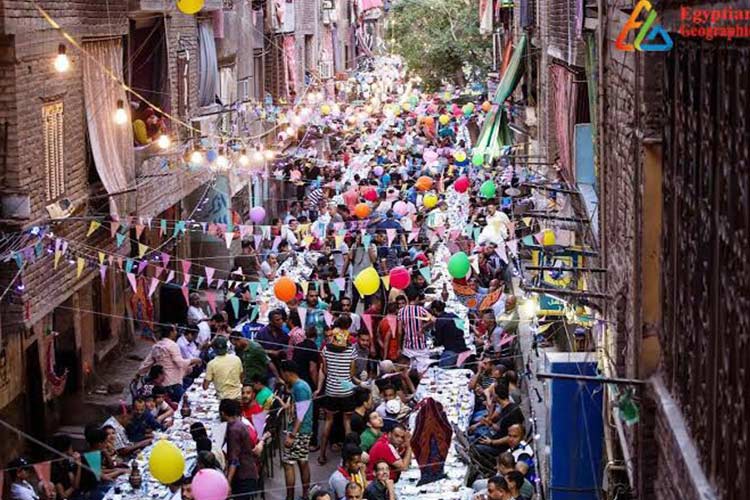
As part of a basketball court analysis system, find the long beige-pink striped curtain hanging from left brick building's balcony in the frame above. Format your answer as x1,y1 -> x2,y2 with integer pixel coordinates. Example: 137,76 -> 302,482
81,40 -> 135,215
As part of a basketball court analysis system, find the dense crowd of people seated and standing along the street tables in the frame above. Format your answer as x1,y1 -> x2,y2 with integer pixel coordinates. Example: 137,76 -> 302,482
2,59 -> 536,500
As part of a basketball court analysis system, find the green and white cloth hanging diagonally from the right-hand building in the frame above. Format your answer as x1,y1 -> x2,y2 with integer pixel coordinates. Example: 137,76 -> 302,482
474,34 -> 526,162
